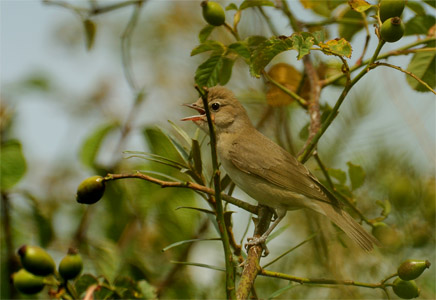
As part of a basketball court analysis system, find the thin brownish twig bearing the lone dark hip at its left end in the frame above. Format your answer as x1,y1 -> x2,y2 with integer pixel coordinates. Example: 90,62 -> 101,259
104,172 -> 258,215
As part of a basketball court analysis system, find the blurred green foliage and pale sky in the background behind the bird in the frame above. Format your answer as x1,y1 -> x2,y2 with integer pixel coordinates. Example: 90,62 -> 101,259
1,1 -> 436,299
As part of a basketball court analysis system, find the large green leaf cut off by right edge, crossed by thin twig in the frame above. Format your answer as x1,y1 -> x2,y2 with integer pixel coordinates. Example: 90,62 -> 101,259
406,42 -> 436,92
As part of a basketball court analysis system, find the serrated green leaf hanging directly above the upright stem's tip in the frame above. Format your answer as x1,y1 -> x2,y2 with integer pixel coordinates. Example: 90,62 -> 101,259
195,54 -> 227,87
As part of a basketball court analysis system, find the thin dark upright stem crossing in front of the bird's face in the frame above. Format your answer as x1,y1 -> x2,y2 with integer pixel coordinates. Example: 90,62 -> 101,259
198,87 -> 236,299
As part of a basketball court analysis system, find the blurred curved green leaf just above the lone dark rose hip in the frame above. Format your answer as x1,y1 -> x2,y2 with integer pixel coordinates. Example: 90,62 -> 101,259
80,123 -> 118,168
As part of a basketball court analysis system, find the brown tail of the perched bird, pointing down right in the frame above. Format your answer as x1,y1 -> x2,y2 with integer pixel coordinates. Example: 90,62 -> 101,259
317,202 -> 380,251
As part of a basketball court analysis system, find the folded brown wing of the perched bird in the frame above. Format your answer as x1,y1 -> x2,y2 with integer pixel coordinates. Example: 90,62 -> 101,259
228,131 -> 339,206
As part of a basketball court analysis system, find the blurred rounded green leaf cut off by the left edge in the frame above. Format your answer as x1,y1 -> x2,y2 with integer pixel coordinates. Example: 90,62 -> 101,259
0,140 -> 27,190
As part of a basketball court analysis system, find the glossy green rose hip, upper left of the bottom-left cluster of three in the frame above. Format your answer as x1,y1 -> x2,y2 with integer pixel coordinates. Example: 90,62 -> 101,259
18,245 -> 56,276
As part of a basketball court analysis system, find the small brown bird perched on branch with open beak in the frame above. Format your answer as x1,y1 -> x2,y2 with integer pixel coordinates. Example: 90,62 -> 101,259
182,86 -> 379,252
